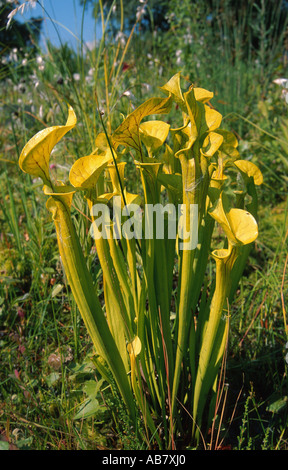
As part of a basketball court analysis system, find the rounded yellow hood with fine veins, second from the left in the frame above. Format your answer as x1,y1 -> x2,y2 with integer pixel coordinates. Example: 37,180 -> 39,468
69,149 -> 113,189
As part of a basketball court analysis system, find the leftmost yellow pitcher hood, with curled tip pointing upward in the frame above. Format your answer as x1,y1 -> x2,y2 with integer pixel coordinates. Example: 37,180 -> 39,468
19,106 -> 77,183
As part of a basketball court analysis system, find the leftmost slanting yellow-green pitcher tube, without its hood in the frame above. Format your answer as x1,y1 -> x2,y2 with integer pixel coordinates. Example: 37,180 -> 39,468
47,196 -> 135,420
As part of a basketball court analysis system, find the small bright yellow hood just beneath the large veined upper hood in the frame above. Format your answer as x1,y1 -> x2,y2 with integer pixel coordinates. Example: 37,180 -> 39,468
140,121 -> 170,156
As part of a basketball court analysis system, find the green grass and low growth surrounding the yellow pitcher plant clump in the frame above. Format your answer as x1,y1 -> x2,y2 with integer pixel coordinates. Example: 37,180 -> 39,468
0,0 -> 288,450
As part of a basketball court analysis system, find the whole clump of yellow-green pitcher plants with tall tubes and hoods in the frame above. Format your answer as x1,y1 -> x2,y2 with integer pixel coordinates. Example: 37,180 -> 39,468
19,73 -> 262,449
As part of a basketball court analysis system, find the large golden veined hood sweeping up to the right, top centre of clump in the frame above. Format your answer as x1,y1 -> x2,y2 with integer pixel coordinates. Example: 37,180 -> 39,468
112,95 -> 172,152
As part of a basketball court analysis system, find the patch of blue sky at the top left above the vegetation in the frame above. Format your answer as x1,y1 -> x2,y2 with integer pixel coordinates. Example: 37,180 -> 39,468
15,0 -> 101,48
